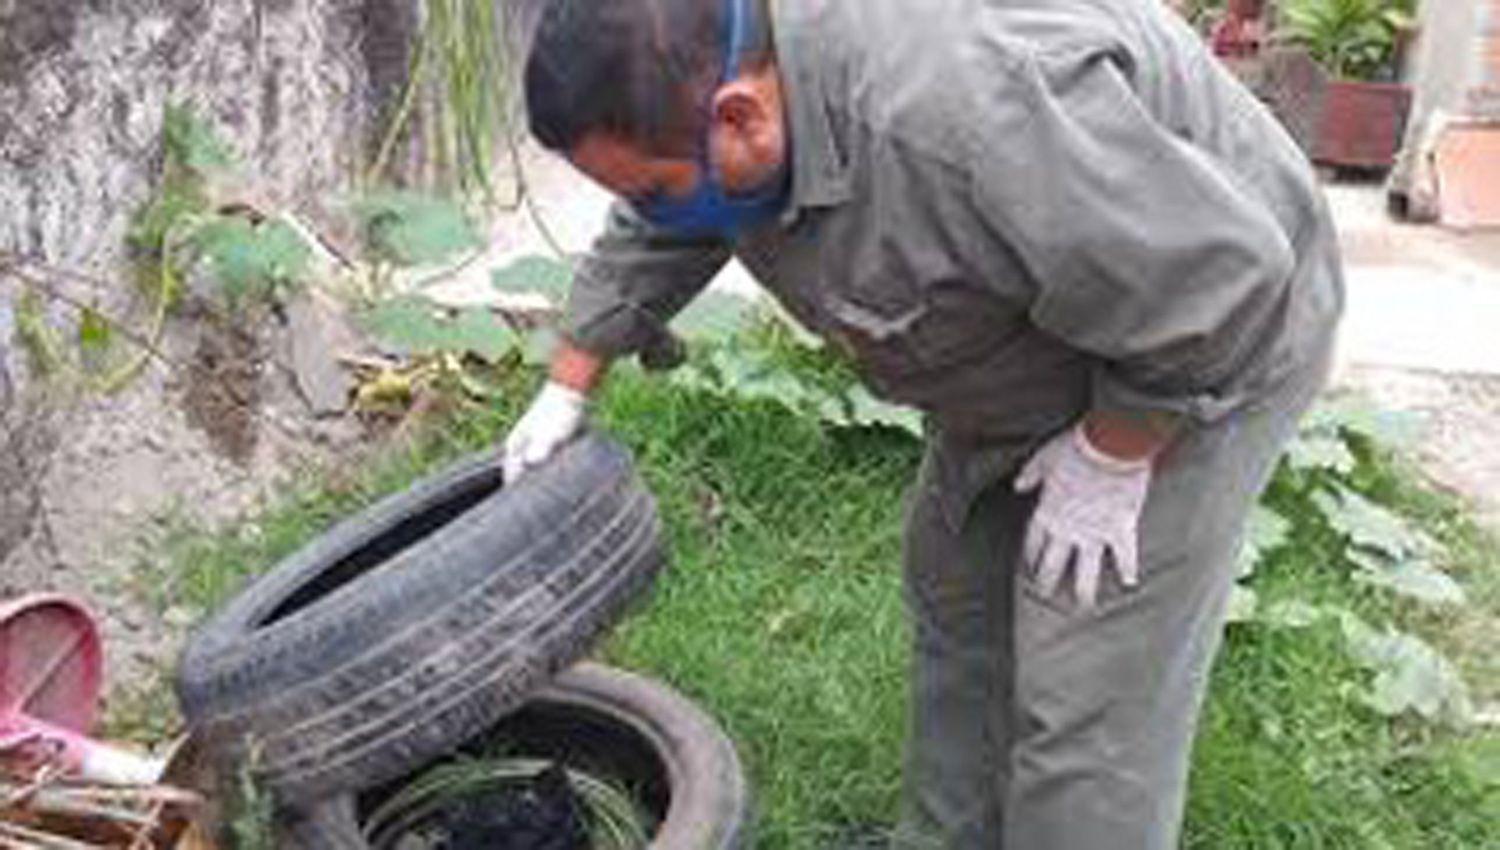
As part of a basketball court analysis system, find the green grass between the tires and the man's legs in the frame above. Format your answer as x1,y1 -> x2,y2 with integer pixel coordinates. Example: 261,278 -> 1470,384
608,376 -> 917,847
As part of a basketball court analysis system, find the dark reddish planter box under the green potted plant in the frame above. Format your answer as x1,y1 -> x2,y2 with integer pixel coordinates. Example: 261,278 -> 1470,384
1313,79 -> 1412,168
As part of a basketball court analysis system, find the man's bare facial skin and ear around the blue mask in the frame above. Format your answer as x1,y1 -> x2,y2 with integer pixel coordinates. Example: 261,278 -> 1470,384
569,66 -> 788,209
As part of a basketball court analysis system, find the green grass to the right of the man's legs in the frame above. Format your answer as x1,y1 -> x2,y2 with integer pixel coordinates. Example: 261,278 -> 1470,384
1185,556 -> 1500,850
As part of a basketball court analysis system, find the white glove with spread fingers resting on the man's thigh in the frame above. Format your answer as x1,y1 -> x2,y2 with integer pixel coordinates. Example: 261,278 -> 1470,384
1016,426 -> 1151,609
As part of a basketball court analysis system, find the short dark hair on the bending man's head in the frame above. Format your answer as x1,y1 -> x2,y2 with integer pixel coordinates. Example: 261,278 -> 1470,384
525,0 -> 771,156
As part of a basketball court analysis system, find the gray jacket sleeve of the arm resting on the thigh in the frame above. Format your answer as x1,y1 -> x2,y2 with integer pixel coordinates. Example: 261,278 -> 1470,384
974,44 -> 1295,423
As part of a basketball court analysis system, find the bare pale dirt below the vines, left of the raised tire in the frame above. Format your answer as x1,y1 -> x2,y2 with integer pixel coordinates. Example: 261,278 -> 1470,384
0,302 -> 362,694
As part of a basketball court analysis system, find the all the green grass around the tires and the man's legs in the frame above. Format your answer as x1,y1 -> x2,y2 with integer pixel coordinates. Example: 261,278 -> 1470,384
129,372 -> 1500,850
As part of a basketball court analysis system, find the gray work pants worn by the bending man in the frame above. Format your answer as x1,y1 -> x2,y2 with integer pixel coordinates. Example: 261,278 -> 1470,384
899,364 -> 1325,850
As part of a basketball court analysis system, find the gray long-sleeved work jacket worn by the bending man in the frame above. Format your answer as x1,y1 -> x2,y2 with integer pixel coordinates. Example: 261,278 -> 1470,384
564,0 -> 1343,522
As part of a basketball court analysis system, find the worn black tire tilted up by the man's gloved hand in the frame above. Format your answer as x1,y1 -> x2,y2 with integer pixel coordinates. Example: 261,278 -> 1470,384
177,435 -> 663,807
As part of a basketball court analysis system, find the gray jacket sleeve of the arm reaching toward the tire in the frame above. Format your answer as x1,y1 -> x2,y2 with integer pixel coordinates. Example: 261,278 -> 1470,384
563,202 -> 731,358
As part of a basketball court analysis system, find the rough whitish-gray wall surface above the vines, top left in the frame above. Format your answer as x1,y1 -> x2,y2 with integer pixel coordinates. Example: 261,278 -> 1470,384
0,0 -> 402,264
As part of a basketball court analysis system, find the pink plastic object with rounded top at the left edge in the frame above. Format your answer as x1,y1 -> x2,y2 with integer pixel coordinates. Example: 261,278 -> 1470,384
0,595 -> 159,783
